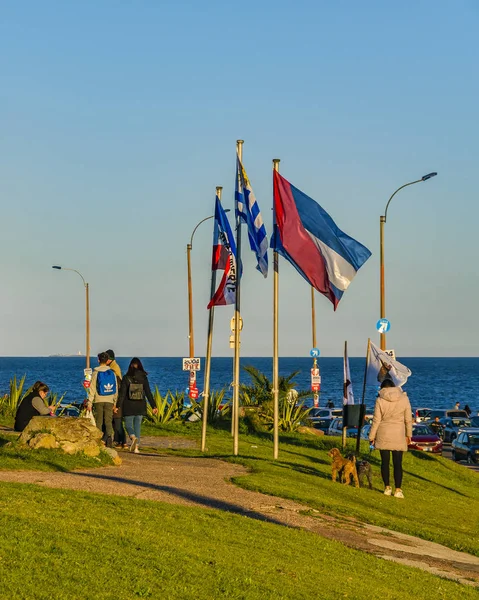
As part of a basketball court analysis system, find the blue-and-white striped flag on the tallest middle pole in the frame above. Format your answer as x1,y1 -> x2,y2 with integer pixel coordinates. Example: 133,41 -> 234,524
235,155 -> 268,277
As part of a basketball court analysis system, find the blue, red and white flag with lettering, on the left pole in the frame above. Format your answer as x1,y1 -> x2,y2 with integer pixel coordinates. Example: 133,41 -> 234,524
207,196 -> 236,309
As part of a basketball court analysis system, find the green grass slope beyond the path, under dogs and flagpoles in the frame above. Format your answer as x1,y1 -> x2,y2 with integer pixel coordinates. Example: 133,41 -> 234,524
142,426 -> 479,556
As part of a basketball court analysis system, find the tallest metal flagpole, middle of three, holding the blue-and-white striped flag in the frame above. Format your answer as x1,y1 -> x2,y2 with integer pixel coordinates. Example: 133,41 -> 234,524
233,140 -> 244,456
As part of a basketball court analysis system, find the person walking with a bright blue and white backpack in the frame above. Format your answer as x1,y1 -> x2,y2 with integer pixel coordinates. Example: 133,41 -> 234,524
88,352 -> 118,448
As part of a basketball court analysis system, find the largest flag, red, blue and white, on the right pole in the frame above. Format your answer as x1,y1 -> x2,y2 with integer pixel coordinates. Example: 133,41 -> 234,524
271,171 -> 371,310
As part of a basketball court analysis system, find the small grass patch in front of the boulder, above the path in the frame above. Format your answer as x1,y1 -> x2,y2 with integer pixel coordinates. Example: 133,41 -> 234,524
0,433 -> 113,471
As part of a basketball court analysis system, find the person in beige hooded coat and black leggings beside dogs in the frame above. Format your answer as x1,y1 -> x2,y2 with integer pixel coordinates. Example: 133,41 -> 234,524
369,379 -> 412,498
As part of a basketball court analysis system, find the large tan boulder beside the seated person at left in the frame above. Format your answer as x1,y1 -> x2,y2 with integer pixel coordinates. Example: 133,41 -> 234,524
19,417 -> 102,457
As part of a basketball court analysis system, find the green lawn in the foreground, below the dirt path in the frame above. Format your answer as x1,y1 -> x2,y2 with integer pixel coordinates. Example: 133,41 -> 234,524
0,483 -> 477,600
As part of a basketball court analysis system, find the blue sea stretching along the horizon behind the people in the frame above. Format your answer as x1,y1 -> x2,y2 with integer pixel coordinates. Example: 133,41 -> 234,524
0,356 -> 479,414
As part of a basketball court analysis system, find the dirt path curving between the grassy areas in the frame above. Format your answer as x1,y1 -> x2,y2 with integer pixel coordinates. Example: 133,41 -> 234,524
0,439 -> 479,587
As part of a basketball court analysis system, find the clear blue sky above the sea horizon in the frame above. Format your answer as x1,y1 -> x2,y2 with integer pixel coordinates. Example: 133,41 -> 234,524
0,0 -> 479,356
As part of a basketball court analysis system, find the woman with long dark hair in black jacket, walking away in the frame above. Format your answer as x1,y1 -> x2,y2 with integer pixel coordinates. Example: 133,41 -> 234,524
117,358 -> 158,454
